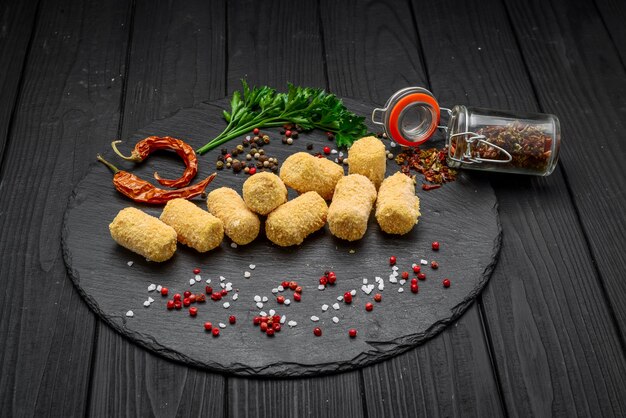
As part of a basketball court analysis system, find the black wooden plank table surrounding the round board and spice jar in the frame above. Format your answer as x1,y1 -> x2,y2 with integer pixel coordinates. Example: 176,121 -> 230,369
0,0 -> 626,417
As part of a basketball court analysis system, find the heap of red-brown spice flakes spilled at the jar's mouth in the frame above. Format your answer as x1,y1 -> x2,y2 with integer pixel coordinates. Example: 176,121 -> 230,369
396,147 -> 456,187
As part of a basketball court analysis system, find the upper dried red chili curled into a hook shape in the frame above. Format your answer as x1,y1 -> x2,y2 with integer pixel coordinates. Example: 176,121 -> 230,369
111,136 -> 198,187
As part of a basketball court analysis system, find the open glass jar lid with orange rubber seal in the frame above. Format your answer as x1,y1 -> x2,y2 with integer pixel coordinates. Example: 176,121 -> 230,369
372,87 -> 440,146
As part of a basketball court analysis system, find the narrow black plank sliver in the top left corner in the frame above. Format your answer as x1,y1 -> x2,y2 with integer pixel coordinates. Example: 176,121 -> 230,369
0,0 -> 38,168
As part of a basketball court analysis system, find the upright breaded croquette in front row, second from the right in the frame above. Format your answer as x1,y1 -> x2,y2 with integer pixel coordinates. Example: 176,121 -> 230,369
328,174 -> 376,241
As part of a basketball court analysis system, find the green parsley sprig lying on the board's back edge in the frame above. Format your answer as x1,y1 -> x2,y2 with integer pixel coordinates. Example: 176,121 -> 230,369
197,80 -> 367,154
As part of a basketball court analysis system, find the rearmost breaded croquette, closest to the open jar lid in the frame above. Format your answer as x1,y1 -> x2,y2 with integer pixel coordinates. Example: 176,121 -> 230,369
348,136 -> 387,190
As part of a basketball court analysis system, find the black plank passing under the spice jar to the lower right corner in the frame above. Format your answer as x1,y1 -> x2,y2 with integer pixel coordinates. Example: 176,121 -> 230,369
415,1 -> 625,416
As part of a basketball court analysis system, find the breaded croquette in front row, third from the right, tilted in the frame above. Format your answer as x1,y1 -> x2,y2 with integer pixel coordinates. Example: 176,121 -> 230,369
265,192 -> 328,247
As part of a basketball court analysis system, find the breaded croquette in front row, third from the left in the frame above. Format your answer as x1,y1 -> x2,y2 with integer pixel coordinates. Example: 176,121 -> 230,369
207,187 -> 261,245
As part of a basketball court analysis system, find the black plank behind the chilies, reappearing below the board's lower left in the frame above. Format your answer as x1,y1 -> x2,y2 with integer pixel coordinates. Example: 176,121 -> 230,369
89,1 -> 225,416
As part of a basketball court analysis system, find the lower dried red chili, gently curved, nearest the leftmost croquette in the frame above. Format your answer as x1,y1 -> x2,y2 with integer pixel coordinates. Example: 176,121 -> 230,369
97,154 -> 217,205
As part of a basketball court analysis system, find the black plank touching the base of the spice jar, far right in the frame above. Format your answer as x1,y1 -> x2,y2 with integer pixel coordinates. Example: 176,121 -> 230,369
506,1 -> 626,336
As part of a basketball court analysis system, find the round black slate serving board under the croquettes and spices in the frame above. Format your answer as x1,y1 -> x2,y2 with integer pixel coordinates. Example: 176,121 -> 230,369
63,99 -> 501,377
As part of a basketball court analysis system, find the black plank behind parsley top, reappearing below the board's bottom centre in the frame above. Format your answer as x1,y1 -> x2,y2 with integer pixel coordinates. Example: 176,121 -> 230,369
223,0 -> 363,416
